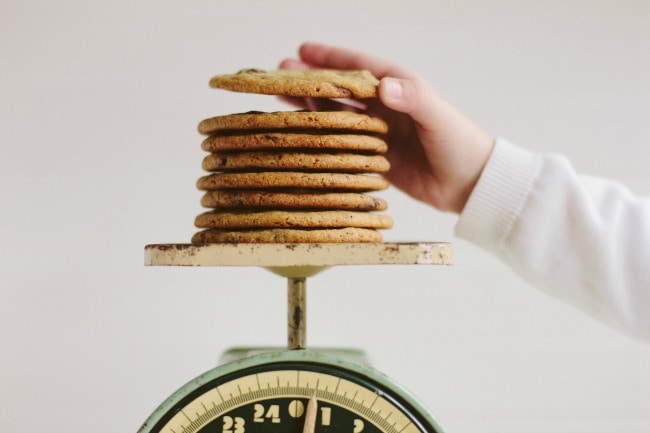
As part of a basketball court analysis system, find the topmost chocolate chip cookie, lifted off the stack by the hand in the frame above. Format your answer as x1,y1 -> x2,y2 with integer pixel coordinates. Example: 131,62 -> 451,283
210,69 -> 379,99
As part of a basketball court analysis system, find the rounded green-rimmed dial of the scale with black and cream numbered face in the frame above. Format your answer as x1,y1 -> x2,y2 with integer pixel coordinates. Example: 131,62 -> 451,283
139,350 -> 442,433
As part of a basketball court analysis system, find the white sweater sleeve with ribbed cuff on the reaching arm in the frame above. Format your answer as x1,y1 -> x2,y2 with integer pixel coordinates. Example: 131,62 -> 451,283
456,139 -> 650,341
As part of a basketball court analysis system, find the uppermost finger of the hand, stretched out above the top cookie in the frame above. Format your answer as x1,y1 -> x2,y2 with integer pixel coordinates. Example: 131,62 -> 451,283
299,43 -> 411,78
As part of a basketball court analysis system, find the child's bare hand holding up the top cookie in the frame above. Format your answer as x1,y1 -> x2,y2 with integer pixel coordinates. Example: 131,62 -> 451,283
280,43 -> 494,213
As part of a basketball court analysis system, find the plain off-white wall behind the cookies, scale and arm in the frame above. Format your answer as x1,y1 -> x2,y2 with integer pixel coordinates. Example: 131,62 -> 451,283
0,0 -> 650,433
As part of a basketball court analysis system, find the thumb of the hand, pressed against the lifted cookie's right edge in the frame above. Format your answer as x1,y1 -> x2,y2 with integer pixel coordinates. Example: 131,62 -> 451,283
379,77 -> 437,128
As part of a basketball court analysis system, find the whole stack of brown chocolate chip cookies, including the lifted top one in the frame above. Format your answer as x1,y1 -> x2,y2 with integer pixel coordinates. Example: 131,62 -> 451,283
192,70 -> 392,243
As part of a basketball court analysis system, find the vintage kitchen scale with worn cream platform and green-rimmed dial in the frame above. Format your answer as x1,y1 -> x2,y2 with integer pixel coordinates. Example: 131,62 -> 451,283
138,242 -> 452,433
